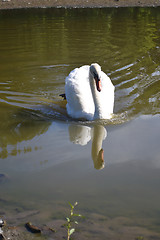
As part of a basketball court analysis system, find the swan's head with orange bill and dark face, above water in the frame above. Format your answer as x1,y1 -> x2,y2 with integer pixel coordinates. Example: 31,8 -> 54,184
90,63 -> 101,92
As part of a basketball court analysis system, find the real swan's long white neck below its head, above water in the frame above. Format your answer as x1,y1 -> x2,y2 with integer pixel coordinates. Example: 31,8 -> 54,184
89,73 -> 102,119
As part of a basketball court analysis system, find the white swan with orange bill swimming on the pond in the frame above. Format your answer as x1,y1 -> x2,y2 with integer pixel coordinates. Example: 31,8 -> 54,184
65,63 -> 114,120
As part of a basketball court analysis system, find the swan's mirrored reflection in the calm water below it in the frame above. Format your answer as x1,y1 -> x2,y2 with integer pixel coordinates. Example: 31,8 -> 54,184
68,125 -> 107,169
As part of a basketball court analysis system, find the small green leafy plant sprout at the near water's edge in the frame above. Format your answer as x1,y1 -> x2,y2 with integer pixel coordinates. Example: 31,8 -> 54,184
64,202 -> 83,240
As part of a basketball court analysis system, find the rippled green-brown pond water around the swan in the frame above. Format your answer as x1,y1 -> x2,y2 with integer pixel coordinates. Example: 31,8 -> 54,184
0,8 -> 160,239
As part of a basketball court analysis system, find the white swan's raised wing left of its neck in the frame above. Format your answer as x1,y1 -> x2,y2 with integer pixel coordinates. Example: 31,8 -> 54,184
65,65 -> 94,120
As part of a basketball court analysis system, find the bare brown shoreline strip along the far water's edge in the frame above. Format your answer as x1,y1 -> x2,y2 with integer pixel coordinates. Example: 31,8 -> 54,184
0,0 -> 160,10
